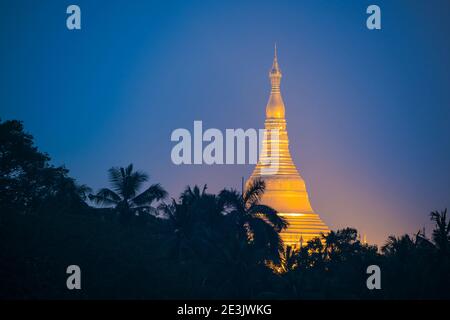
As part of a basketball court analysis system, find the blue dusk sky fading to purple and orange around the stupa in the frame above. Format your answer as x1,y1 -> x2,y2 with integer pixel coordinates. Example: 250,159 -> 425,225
0,0 -> 450,244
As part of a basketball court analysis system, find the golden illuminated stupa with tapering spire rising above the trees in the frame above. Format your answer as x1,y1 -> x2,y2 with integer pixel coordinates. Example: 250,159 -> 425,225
246,47 -> 330,247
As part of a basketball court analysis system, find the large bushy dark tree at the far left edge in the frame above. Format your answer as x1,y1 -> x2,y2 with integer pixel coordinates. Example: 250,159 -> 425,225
0,120 -> 86,213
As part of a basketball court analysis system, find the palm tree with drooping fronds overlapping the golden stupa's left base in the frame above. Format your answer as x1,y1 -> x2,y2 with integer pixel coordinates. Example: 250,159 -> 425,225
219,179 -> 288,263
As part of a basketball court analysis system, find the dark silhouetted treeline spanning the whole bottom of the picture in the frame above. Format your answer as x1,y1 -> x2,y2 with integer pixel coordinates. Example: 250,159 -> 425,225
0,121 -> 450,299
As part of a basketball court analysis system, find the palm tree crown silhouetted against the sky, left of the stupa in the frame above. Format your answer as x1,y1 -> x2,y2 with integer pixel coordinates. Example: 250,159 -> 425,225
89,164 -> 167,222
